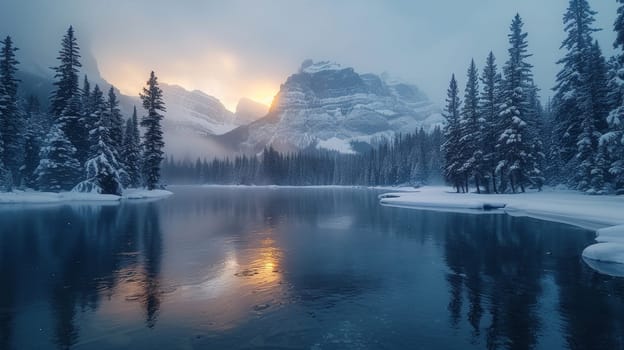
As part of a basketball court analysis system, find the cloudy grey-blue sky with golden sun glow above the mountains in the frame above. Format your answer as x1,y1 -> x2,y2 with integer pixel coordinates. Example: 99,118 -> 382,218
0,0 -> 617,110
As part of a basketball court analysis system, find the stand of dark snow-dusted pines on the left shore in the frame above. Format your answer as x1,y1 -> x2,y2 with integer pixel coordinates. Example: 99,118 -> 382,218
0,26 -> 165,195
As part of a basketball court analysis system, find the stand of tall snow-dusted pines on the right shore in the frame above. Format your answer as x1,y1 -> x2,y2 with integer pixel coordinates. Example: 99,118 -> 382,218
442,0 -> 624,194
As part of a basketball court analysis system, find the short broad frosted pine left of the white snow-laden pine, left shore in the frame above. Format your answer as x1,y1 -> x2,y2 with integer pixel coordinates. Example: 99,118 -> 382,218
35,124 -> 82,192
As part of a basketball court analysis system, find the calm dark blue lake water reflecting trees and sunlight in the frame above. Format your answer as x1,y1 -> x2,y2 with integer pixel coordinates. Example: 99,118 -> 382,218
0,188 -> 624,350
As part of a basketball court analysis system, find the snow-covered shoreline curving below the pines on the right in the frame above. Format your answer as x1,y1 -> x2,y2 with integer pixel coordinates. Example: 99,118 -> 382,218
379,187 -> 624,276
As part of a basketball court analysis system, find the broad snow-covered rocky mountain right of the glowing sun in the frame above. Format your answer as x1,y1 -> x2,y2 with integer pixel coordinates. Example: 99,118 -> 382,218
218,60 -> 443,153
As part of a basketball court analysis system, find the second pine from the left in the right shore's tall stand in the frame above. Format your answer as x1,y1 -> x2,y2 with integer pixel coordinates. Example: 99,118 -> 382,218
459,60 -> 485,193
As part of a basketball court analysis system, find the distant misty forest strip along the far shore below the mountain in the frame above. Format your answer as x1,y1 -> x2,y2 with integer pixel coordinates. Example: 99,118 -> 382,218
163,128 -> 443,186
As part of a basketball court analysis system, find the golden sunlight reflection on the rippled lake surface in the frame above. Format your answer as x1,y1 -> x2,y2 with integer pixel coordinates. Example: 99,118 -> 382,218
104,230 -> 287,331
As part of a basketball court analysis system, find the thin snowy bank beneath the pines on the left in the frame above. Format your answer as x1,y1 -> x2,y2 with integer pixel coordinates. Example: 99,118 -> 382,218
0,189 -> 173,205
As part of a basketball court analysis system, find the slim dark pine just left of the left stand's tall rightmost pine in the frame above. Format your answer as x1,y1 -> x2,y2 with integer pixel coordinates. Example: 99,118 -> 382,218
122,106 -> 141,188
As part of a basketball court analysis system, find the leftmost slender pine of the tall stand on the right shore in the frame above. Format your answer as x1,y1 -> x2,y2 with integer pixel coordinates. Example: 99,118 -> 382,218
442,74 -> 467,193
